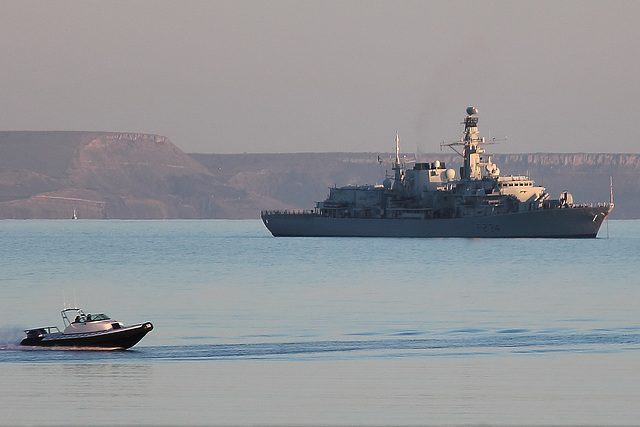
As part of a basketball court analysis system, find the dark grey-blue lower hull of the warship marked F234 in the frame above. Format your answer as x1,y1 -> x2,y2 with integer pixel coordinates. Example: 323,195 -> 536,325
262,205 -> 611,238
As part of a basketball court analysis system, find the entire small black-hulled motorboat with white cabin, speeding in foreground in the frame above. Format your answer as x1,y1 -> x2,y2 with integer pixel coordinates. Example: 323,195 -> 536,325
20,308 -> 153,350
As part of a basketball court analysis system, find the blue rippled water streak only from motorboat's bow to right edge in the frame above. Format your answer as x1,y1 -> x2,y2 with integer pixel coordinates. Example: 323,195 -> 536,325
145,330 -> 640,360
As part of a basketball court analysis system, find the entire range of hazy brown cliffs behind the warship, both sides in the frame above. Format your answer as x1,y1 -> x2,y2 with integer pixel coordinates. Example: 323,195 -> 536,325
0,132 -> 640,219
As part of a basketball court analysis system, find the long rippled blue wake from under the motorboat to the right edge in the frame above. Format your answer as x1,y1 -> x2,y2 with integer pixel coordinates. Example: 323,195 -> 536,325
5,328 -> 640,362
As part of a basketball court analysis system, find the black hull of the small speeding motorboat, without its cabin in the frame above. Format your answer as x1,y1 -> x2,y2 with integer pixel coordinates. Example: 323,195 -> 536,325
20,322 -> 153,350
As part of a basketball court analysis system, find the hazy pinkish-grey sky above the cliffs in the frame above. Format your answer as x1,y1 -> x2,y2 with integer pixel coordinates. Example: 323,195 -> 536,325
0,0 -> 640,153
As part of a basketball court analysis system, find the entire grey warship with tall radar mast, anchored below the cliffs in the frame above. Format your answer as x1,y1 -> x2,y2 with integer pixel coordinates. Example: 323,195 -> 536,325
261,107 -> 613,238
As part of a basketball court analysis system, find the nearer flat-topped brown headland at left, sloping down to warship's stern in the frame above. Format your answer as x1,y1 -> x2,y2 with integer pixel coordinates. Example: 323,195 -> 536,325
0,132 -> 281,219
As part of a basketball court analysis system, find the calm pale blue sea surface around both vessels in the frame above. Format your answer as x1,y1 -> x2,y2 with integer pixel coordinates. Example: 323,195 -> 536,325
0,219 -> 640,426
